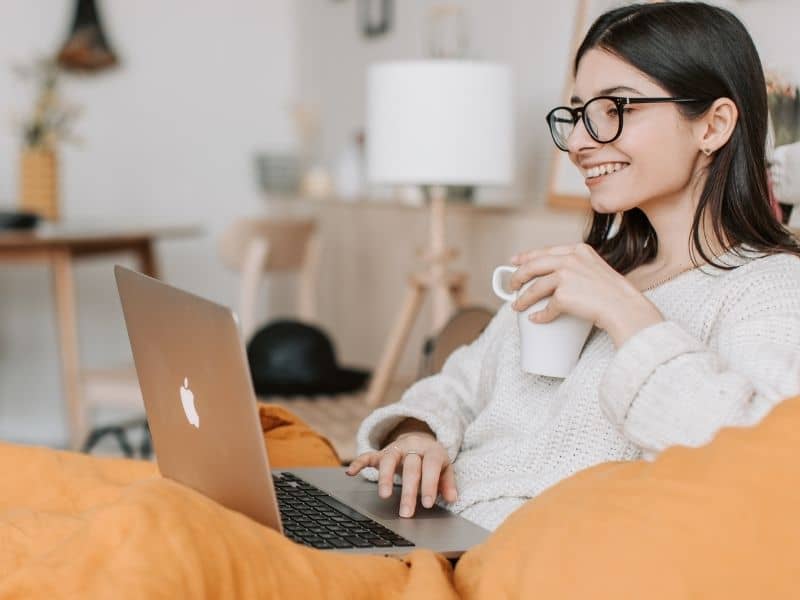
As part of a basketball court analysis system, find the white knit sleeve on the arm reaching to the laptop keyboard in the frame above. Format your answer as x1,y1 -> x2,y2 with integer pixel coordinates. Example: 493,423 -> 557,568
357,304 -> 515,466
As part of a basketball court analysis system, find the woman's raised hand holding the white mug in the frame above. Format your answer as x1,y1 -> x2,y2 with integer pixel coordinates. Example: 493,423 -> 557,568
510,244 -> 664,348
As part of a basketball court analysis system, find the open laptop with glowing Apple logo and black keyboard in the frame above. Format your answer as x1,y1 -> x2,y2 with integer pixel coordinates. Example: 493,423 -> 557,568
114,266 -> 489,558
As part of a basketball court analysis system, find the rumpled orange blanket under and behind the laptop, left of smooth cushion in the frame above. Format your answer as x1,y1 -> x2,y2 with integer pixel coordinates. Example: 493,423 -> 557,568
0,406 -> 455,599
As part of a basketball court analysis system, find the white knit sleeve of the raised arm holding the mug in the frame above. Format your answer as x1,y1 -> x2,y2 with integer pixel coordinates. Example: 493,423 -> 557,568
599,257 -> 800,456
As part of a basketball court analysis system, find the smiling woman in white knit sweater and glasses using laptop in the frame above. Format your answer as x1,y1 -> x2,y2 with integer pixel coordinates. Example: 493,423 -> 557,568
348,2 -> 800,529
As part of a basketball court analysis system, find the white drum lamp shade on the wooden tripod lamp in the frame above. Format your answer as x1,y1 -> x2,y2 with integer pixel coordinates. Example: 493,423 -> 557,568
366,60 -> 514,185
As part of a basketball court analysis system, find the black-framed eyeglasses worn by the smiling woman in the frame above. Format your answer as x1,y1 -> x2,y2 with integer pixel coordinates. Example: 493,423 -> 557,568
546,96 -> 699,152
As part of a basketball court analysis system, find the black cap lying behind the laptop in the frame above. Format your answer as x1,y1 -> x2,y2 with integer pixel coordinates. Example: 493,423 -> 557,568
247,319 -> 370,396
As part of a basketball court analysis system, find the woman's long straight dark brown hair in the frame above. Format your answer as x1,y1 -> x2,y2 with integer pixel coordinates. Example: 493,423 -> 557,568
574,2 -> 800,274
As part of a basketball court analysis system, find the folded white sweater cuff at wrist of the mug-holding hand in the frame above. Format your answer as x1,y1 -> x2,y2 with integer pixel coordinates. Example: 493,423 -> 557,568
599,321 -> 705,427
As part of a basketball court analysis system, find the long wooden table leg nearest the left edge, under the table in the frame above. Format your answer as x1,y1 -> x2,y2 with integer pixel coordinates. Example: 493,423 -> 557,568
50,250 -> 86,450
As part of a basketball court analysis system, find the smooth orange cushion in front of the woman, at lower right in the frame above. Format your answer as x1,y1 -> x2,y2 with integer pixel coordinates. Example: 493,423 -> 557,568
455,397 -> 800,600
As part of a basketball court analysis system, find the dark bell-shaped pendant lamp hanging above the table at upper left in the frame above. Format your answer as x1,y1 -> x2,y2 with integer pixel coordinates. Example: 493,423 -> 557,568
57,0 -> 118,72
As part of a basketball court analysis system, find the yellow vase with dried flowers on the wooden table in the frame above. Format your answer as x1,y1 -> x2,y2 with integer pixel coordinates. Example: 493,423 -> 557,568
19,148 -> 59,221
